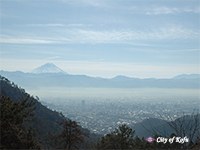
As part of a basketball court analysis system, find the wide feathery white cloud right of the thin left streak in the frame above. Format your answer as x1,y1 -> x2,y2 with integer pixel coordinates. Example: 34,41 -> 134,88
63,25 -> 200,43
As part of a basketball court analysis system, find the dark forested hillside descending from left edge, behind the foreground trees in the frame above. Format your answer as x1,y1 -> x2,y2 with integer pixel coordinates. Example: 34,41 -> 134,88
0,76 -> 97,148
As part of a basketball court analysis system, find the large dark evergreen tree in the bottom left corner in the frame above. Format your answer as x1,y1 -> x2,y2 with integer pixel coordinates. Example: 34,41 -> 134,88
0,95 -> 40,149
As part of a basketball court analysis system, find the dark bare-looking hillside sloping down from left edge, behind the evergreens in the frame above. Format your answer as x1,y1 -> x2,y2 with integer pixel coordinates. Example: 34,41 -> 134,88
0,76 -> 98,148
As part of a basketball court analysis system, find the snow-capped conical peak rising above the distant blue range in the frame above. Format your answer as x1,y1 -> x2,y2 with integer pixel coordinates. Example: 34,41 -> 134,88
31,63 -> 67,74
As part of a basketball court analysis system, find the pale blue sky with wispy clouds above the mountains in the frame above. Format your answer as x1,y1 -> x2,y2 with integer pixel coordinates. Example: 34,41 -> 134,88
0,0 -> 200,78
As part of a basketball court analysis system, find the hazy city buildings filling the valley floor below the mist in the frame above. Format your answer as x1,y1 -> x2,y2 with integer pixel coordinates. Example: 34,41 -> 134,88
41,97 -> 199,134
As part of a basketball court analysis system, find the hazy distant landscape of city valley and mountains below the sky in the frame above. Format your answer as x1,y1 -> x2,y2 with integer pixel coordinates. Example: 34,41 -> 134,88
0,63 -> 200,137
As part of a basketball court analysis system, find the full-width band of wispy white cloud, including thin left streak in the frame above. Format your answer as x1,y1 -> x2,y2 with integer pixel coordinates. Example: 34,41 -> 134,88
0,25 -> 200,45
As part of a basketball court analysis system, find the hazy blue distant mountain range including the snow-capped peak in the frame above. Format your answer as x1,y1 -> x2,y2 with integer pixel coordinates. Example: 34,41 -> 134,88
0,63 -> 200,89
